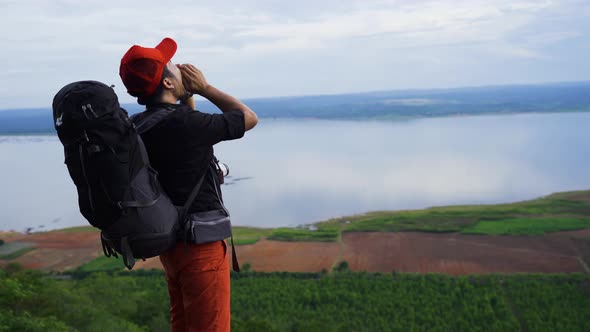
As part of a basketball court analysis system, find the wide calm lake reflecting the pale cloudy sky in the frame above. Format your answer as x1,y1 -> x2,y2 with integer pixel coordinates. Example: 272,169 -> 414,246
0,113 -> 590,231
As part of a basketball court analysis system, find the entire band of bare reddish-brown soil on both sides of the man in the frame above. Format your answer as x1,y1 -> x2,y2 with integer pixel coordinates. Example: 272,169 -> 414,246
0,230 -> 590,275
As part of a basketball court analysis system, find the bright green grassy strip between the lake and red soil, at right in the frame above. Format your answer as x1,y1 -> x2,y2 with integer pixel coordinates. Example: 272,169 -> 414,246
269,191 -> 590,241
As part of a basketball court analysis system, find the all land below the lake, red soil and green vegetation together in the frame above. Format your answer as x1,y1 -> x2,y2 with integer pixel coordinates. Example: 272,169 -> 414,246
0,192 -> 590,332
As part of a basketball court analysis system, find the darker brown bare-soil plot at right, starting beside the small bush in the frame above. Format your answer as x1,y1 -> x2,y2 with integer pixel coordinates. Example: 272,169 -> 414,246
342,232 -> 588,275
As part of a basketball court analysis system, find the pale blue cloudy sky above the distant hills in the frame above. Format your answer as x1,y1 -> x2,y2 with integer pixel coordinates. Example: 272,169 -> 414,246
0,0 -> 590,109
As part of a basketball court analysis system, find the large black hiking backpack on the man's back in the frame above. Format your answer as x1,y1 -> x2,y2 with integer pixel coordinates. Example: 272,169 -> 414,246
53,81 -> 183,269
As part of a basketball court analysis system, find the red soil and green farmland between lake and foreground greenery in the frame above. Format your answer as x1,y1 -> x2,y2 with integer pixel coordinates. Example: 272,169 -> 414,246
0,191 -> 590,275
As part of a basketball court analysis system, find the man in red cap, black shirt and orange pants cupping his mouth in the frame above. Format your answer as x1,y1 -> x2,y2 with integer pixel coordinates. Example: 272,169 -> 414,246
119,38 -> 258,332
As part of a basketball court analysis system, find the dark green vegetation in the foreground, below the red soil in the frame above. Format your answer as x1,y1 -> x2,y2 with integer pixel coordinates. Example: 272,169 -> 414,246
0,269 -> 590,332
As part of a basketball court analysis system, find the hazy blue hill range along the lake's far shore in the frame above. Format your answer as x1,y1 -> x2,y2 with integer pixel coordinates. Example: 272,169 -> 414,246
0,82 -> 590,134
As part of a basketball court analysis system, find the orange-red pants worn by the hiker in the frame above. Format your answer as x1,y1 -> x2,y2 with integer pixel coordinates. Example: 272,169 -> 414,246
160,241 -> 230,332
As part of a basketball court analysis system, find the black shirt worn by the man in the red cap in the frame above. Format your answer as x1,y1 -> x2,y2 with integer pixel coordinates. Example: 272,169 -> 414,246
139,104 -> 245,213
